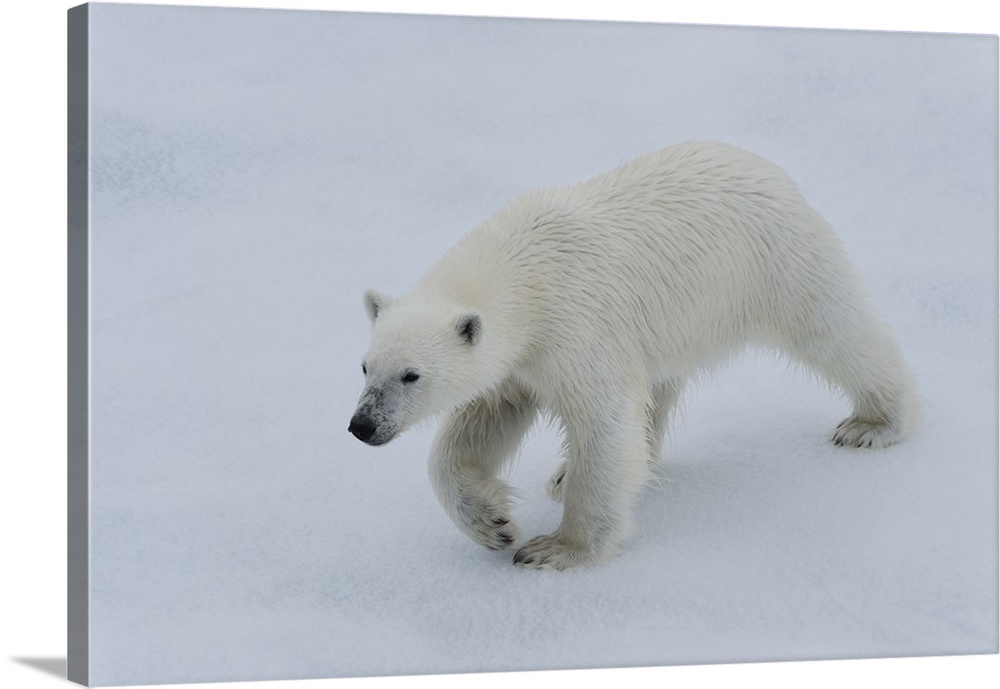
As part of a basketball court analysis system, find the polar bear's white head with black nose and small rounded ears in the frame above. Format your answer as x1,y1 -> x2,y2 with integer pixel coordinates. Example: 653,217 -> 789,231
348,290 -> 483,445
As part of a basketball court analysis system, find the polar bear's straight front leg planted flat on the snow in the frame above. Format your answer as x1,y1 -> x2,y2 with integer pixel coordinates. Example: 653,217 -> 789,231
514,400 -> 649,570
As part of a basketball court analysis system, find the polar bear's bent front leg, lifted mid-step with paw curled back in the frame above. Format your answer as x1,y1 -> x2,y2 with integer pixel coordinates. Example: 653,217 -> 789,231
430,384 -> 536,550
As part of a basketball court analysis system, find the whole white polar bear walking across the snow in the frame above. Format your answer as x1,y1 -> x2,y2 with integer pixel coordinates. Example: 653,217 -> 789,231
349,142 -> 915,570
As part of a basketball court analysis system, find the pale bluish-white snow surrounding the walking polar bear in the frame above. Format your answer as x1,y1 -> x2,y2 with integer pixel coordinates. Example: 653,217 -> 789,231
84,4 -> 998,684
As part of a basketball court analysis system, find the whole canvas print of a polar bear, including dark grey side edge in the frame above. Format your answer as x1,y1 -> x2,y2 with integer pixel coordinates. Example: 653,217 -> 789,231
68,3 -> 998,685
